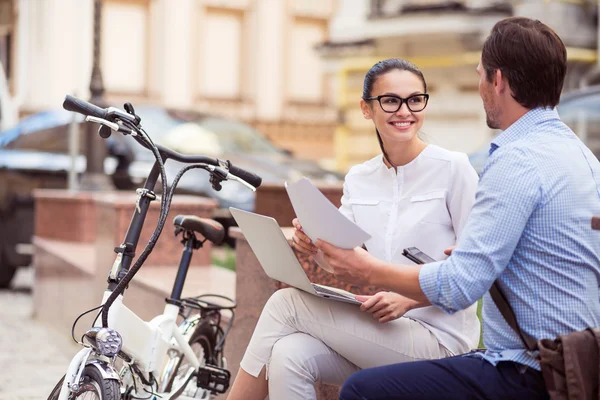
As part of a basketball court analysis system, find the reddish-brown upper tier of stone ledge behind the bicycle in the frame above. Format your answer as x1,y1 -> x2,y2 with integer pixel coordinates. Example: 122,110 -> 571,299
34,189 -> 218,266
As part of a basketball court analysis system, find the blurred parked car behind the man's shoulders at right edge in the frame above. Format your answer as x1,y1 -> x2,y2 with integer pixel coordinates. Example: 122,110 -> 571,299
469,85 -> 600,174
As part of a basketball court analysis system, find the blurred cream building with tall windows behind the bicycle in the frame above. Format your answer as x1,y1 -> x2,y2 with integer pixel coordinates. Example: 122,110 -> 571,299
0,0 -> 337,166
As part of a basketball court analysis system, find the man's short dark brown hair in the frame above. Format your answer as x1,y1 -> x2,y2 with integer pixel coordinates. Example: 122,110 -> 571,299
481,17 -> 567,109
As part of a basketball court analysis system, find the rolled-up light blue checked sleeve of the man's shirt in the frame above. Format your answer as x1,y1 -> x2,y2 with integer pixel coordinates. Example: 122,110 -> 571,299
419,146 -> 542,314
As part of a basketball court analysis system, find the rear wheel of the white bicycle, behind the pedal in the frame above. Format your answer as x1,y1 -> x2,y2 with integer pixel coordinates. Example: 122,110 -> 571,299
168,322 -> 221,398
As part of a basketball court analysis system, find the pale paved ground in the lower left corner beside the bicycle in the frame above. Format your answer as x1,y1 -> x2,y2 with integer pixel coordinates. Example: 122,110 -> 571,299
0,268 -> 78,400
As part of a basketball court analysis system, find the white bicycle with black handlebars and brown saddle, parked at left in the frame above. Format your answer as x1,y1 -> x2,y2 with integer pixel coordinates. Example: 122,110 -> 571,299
48,96 -> 262,400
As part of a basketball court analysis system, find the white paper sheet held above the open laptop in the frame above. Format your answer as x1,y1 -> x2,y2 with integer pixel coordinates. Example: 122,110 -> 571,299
285,178 -> 371,249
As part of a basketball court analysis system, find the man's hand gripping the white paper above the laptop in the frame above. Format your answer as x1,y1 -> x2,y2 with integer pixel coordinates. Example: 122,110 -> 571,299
315,239 -> 379,286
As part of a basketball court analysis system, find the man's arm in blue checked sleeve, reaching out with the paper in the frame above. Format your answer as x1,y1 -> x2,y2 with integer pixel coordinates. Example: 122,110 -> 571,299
317,147 -> 542,313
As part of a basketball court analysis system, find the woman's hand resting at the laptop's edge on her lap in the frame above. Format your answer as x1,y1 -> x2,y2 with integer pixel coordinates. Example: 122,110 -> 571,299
355,292 -> 419,323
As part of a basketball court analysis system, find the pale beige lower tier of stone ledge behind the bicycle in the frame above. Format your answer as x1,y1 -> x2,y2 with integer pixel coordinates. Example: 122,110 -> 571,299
33,237 -> 235,335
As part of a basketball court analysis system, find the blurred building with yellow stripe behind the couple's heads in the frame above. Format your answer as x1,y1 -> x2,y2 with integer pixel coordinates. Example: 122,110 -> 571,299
319,0 -> 600,170
